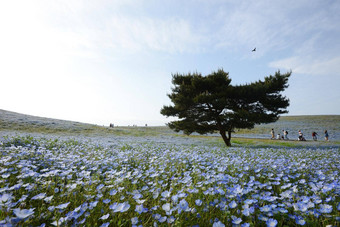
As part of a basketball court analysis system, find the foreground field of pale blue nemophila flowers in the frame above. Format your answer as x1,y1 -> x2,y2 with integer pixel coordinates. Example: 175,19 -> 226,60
0,137 -> 340,226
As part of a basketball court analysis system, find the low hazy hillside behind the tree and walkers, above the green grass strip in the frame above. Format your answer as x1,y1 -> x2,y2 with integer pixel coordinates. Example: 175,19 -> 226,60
0,109 -> 340,141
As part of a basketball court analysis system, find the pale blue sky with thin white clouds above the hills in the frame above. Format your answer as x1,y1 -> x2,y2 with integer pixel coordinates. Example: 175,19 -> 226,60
0,0 -> 340,125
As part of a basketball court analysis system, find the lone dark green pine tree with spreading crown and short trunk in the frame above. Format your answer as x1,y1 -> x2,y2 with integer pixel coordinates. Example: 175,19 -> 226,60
161,69 -> 291,146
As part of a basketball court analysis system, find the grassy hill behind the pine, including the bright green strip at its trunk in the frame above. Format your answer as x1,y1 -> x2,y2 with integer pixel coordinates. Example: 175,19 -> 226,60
0,109 -> 340,146
